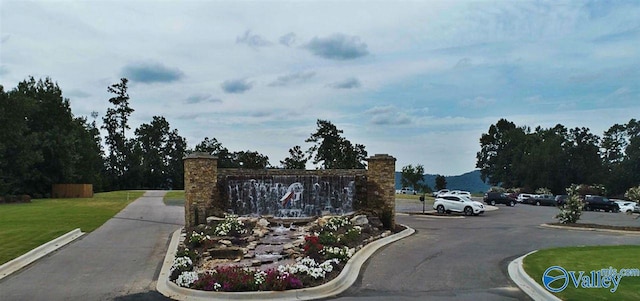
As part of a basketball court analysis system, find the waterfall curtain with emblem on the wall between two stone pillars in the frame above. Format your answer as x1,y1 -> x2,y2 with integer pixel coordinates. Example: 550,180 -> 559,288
226,176 -> 355,218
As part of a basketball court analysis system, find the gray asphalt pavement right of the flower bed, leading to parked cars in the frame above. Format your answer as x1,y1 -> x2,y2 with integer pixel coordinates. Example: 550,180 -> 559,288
336,205 -> 640,301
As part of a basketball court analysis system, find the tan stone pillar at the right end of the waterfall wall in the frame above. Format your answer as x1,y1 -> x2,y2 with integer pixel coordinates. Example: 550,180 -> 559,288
367,154 -> 396,229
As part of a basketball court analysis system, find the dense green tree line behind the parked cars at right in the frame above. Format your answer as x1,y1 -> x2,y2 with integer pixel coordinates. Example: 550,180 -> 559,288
476,119 -> 640,196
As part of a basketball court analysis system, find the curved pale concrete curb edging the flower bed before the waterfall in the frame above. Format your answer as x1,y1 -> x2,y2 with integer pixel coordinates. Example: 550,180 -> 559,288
156,226 -> 415,301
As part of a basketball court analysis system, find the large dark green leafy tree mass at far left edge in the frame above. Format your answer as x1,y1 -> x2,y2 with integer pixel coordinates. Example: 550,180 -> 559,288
0,77 -> 102,197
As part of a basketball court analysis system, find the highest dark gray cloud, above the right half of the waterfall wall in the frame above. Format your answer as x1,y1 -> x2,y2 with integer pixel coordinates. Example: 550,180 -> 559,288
306,33 -> 369,60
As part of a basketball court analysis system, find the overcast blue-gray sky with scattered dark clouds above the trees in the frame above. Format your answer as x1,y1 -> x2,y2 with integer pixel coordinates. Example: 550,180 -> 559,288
0,0 -> 640,175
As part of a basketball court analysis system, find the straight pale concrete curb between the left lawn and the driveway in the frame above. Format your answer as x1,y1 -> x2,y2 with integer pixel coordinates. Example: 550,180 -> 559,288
0,228 -> 84,280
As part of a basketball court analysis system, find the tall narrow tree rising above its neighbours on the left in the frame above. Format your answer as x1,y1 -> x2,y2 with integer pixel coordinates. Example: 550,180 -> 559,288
102,78 -> 134,189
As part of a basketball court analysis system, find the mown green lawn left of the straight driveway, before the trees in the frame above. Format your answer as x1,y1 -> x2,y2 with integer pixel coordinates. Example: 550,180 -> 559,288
0,191 -> 144,264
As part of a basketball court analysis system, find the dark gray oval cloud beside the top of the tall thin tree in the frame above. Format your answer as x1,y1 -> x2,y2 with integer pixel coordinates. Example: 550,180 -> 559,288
122,62 -> 184,84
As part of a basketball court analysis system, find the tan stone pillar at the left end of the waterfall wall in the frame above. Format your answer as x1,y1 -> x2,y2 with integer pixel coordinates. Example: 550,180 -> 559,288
184,153 -> 218,228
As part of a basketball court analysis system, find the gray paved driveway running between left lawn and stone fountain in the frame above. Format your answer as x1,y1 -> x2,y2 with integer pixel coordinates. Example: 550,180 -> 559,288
0,191 -> 184,301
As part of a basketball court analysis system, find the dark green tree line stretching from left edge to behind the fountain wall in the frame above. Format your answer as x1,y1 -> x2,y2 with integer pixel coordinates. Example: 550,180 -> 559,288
0,77 -> 367,198
